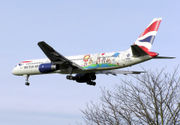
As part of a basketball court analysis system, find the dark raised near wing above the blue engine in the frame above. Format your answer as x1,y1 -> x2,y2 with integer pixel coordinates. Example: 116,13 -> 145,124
38,41 -> 83,70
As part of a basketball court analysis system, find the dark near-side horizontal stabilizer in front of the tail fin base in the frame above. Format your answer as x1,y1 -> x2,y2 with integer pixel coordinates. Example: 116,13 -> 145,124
131,45 -> 148,57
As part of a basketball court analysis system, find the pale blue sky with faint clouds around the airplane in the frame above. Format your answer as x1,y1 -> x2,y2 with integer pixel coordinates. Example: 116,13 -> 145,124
0,0 -> 180,125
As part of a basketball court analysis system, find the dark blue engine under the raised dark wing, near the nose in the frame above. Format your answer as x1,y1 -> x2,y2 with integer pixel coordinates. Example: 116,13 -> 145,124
39,63 -> 57,73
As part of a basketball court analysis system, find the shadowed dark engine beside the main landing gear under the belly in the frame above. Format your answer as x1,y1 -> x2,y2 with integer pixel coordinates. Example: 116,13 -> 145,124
74,73 -> 96,83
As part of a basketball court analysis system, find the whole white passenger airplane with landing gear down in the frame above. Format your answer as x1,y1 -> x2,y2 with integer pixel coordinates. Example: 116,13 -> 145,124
12,18 -> 175,86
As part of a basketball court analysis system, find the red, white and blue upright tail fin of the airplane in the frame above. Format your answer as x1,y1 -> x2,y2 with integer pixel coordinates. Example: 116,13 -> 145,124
134,18 -> 162,50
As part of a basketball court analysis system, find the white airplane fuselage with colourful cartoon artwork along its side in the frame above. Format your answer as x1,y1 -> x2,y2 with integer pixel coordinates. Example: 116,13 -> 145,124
12,48 -> 152,75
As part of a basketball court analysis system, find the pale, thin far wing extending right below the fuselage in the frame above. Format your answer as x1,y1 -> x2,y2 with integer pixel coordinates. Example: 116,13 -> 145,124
96,70 -> 146,76
